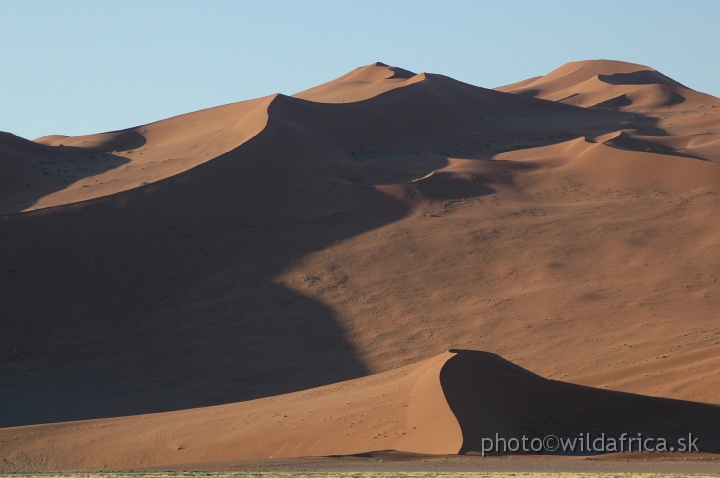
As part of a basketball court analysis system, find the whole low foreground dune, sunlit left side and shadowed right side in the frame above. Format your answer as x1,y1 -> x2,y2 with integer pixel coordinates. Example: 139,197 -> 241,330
0,350 -> 720,471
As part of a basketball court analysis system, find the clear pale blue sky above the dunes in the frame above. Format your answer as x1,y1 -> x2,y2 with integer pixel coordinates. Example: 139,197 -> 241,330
0,0 -> 720,139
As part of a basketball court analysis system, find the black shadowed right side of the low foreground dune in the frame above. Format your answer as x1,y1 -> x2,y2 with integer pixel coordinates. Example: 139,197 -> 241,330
440,350 -> 720,455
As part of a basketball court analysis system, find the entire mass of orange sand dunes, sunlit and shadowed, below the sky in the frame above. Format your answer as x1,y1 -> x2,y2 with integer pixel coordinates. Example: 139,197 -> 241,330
0,61 -> 720,469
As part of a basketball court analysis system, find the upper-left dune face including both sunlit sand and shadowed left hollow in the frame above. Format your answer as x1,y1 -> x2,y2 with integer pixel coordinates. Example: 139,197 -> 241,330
0,95 -> 278,215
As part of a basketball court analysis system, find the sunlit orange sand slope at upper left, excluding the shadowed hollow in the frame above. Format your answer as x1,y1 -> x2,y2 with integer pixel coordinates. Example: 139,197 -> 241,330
11,95 -> 277,211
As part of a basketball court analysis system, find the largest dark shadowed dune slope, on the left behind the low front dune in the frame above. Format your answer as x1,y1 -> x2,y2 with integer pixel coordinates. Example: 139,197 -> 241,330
0,95 -> 406,425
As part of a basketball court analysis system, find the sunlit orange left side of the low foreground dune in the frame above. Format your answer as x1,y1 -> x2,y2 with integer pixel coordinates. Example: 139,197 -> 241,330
0,353 -> 462,471
